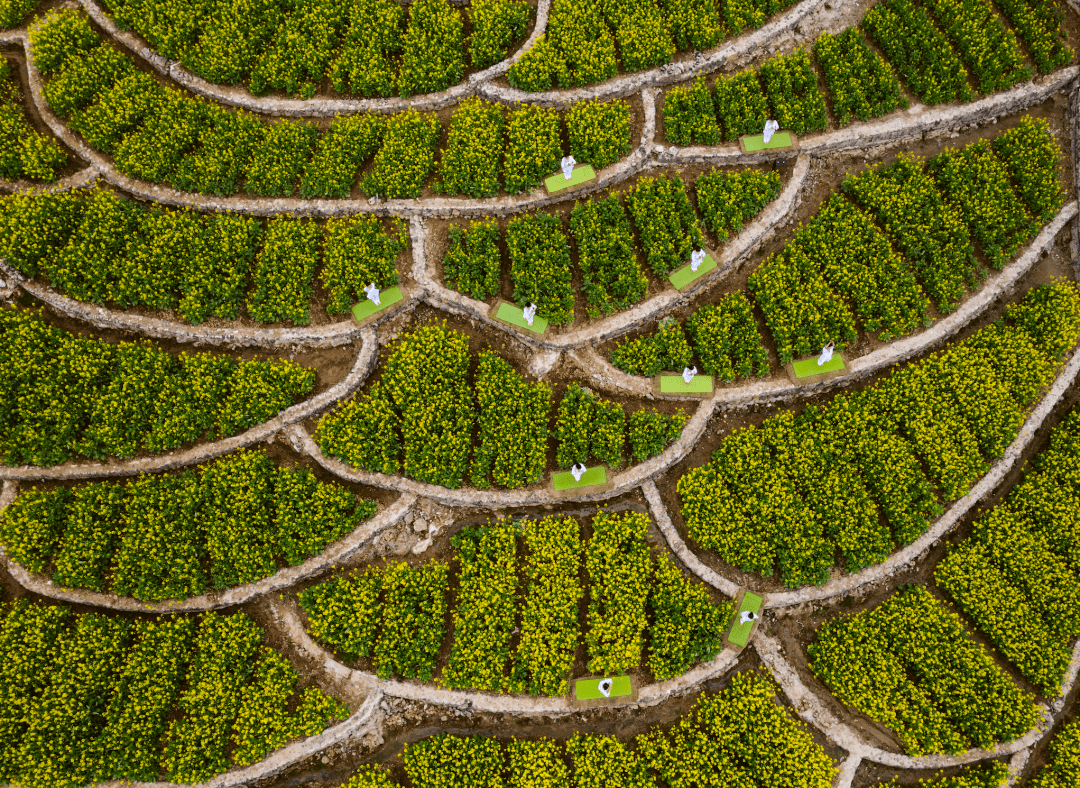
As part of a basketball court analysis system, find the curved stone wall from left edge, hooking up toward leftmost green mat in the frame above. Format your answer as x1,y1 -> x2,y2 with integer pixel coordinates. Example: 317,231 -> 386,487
0,328 -> 379,480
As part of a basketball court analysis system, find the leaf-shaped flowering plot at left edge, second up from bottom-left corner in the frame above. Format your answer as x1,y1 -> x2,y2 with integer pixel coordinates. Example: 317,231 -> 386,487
0,450 -> 376,600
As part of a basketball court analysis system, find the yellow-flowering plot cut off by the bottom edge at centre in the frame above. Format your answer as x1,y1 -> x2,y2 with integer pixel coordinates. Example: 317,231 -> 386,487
341,671 -> 836,788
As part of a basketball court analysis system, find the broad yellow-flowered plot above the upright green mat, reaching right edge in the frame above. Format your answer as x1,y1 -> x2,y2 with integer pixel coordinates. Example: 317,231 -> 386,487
677,281 -> 1080,586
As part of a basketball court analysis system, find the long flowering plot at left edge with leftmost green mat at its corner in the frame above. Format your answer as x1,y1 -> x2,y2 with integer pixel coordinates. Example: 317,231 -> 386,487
0,189 -> 408,325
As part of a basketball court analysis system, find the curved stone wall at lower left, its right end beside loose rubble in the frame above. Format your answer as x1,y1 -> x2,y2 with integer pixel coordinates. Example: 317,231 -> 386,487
0,480 -> 417,613
